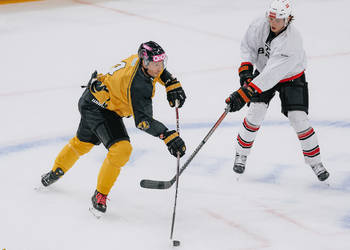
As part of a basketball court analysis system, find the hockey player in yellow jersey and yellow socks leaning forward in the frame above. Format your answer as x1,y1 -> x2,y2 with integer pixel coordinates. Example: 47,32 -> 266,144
41,41 -> 186,213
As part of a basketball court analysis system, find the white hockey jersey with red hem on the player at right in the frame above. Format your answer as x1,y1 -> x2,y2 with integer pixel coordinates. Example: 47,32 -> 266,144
241,18 -> 306,93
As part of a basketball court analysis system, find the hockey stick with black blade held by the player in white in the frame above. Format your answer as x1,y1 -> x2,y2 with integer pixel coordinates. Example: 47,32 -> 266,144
140,104 -> 230,189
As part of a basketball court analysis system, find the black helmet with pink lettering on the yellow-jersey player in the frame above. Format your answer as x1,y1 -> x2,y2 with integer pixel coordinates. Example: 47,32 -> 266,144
137,41 -> 167,65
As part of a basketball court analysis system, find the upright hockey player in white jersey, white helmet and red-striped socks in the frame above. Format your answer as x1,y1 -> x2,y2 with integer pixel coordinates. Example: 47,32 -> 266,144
226,0 -> 329,181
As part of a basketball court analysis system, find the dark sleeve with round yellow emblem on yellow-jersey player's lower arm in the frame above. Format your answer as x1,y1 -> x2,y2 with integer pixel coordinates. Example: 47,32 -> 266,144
130,80 -> 168,136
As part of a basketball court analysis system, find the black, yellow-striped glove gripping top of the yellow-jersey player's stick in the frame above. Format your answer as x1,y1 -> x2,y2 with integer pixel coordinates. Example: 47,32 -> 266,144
160,69 -> 186,108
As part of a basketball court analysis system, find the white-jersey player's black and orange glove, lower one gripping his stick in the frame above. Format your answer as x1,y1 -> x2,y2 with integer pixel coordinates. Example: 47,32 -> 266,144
225,87 -> 254,112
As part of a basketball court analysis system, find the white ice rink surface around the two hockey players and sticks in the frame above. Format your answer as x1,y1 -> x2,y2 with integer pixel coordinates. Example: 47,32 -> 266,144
0,0 -> 350,250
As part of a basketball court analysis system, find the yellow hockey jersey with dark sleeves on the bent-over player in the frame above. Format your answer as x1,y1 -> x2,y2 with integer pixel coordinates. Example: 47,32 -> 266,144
89,55 -> 167,136
